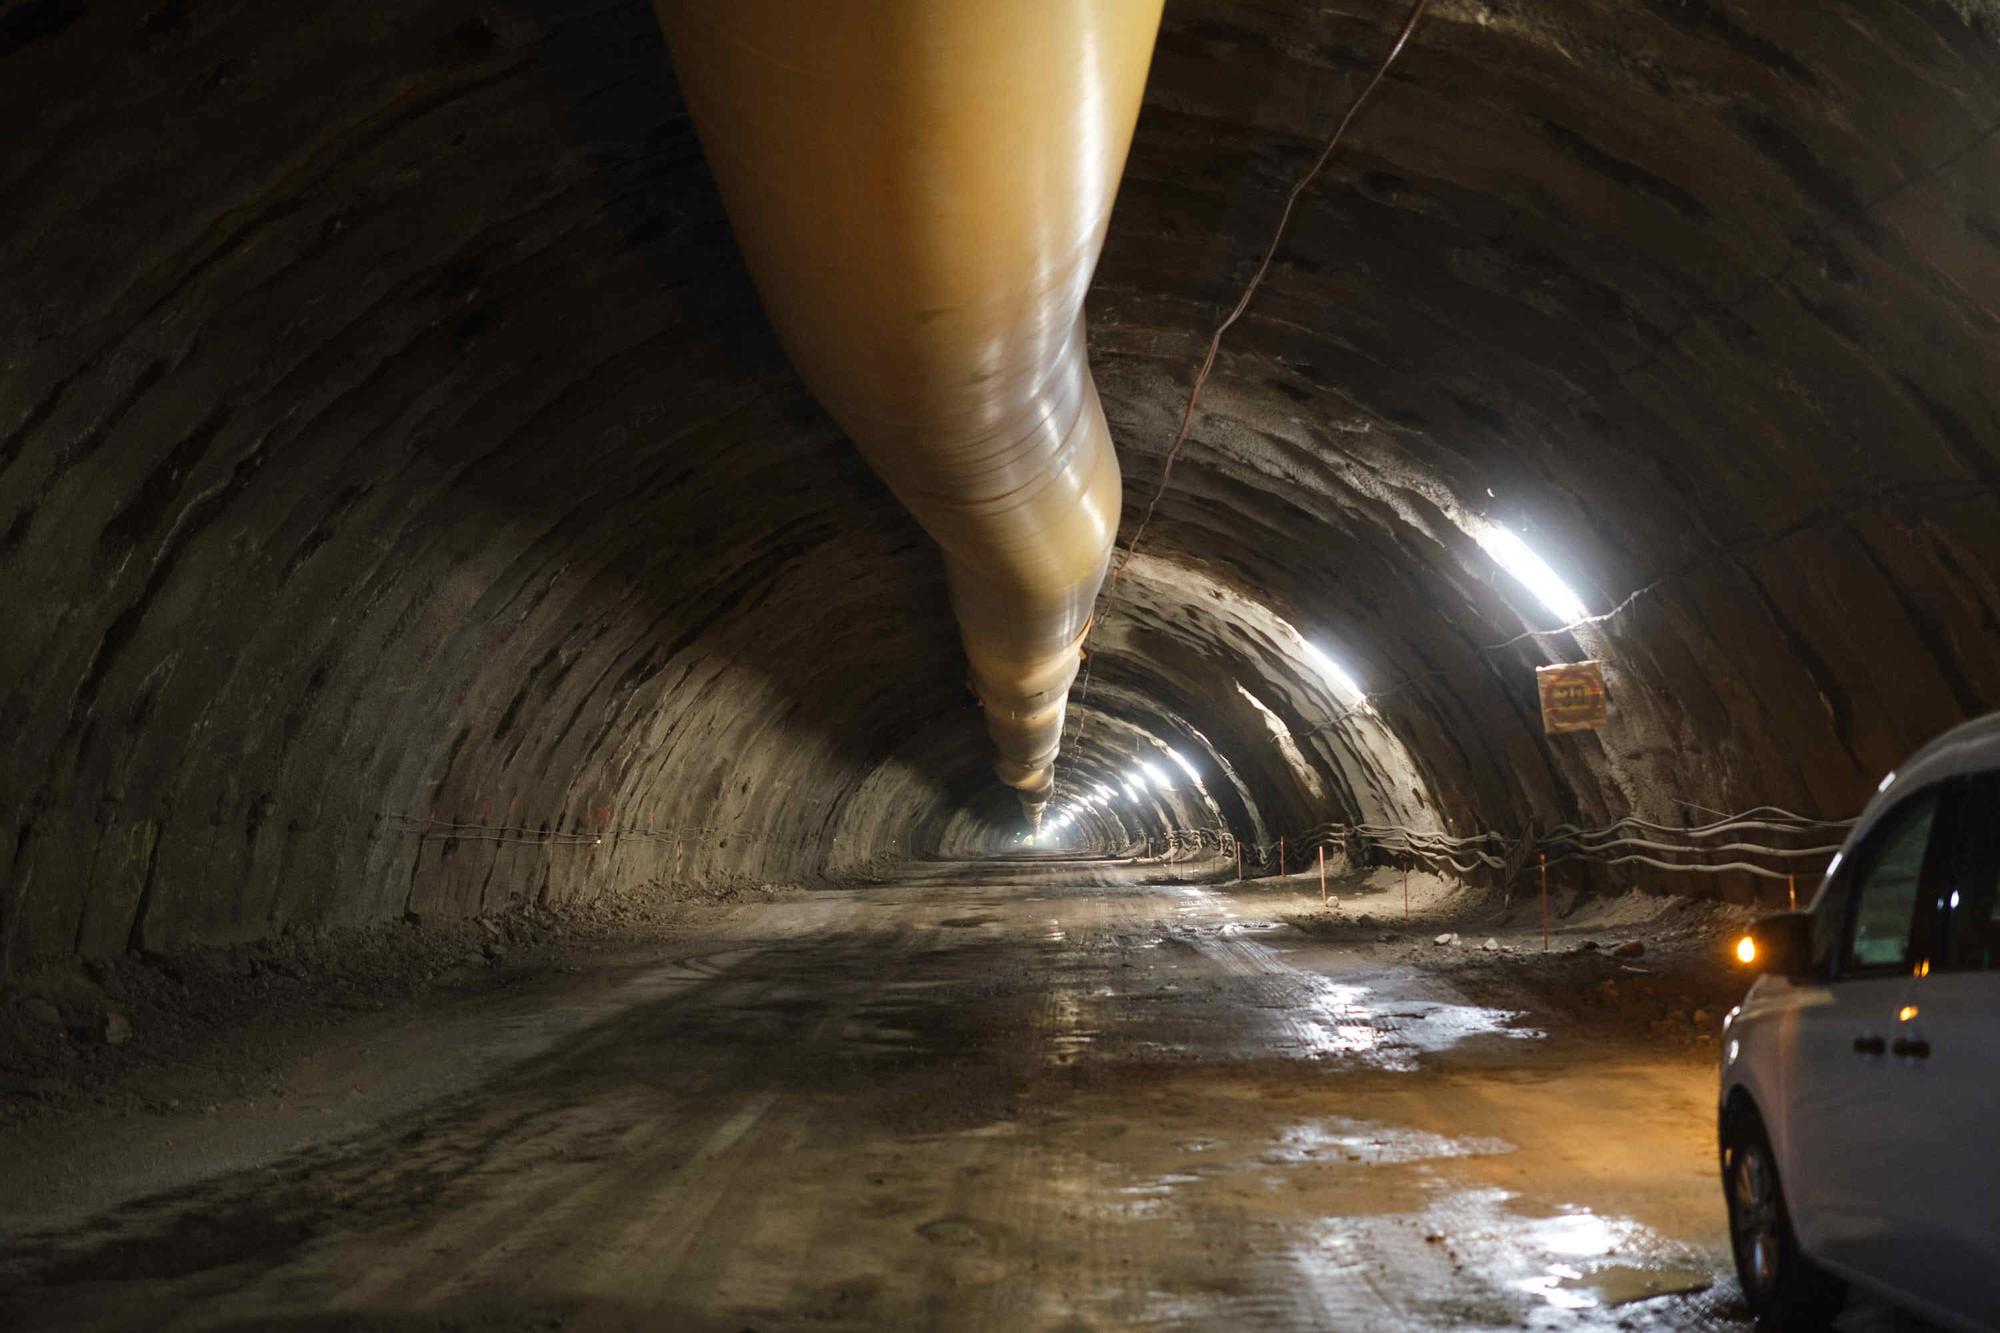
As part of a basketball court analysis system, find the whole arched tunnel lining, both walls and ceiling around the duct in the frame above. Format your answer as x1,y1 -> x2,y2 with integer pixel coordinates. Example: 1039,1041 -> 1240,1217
0,0 -> 2000,967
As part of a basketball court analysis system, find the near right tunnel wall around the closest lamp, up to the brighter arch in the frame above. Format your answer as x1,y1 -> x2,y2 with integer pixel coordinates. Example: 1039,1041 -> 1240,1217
1090,0 -> 2000,852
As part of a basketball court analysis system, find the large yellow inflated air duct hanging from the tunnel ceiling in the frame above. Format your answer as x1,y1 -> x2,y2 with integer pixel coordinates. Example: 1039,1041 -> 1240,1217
658,0 -> 1162,821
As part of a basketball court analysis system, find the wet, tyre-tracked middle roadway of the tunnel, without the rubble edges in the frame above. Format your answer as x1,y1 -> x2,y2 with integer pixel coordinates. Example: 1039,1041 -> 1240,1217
0,867 -> 1904,1329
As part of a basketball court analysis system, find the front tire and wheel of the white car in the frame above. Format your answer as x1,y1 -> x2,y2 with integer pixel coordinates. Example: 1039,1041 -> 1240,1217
1722,1107 -> 1848,1333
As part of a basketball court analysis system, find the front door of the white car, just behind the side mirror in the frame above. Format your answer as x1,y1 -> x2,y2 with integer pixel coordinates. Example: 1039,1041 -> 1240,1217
1784,787 -> 1942,1287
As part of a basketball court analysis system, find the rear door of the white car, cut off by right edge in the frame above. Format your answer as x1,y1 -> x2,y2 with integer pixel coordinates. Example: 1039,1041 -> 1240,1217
1890,773 -> 2000,1323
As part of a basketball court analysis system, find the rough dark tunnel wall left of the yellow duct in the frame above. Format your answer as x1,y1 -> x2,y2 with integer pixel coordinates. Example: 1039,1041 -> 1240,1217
0,6 -> 984,961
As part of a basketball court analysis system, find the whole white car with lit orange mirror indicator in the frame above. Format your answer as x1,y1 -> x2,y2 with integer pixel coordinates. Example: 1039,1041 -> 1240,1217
1720,715 -> 2000,1329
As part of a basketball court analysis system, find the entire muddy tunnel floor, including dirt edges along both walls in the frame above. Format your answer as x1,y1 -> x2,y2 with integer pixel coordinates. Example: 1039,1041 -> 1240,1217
0,863 -> 1936,1329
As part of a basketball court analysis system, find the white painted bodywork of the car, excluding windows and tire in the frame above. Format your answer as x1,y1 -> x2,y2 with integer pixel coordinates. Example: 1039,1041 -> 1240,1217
1720,715 -> 2000,1329
